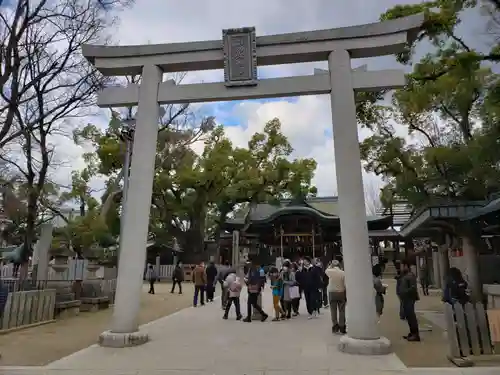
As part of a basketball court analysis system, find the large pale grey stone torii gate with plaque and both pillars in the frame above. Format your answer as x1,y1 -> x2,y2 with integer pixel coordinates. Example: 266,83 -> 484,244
83,15 -> 424,354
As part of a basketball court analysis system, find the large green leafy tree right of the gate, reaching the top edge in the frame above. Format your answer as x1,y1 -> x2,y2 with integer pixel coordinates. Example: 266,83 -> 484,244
358,0 -> 500,207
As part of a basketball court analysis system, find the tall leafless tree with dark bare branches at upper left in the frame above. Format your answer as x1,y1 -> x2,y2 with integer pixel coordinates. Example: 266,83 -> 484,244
0,0 -> 132,259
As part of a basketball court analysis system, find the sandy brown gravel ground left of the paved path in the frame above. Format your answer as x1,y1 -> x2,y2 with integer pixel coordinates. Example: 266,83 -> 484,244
0,283 -> 193,366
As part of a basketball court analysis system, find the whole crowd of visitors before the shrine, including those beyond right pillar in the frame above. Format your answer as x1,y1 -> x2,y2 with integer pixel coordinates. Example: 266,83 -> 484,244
157,257 -> 476,342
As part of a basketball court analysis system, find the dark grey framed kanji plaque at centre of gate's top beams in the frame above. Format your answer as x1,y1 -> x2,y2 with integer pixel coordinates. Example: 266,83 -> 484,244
222,27 -> 257,87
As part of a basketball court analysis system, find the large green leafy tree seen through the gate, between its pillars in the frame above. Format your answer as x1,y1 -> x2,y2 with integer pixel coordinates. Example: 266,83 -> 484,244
148,119 -> 316,252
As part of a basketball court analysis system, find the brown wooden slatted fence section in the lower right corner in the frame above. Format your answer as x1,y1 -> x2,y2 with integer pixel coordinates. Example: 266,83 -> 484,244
445,302 -> 493,366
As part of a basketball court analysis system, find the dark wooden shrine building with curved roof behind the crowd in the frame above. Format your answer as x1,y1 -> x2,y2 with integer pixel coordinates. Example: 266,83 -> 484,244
219,197 -> 400,264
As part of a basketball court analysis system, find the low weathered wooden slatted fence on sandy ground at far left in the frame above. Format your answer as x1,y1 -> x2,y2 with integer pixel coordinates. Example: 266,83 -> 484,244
0,289 -> 56,332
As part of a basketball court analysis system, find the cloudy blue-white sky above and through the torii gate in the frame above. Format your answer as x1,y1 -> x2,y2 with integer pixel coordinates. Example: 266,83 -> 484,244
51,0 -> 488,203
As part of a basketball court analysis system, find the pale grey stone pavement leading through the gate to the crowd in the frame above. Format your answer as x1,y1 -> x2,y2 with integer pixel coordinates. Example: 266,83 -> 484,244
0,291 -> 500,375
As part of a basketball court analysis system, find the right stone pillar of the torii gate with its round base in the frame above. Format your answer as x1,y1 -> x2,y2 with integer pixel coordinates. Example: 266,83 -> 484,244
328,50 -> 391,355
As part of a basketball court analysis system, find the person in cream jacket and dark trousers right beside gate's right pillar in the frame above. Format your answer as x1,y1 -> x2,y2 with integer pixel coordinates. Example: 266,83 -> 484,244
326,260 -> 347,335
